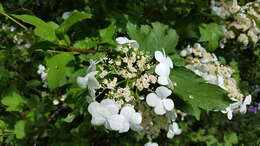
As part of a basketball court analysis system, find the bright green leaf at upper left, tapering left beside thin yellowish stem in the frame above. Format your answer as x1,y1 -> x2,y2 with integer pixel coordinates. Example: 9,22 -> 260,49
12,14 -> 58,42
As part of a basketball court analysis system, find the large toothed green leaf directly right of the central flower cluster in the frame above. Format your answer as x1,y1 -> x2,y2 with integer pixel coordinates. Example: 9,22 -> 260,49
170,68 -> 229,110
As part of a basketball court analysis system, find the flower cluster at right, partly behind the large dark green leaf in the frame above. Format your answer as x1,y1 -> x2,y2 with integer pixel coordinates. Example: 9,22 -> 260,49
180,43 -> 251,119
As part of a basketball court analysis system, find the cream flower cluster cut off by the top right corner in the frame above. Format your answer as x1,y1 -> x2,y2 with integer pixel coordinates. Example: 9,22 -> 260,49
211,0 -> 260,47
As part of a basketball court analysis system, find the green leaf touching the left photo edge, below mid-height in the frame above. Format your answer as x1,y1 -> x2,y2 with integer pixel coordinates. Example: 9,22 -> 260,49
1,91 -> 27,111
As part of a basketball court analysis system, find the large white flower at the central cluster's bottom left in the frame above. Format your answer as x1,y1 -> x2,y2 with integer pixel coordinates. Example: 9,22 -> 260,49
88,99 -> 119,129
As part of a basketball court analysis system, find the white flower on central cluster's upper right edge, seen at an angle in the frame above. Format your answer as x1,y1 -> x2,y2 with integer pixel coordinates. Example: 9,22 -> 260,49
154,50 -> 173,85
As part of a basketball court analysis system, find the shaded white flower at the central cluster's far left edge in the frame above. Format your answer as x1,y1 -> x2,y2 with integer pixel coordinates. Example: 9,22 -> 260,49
77,71 -> 100,97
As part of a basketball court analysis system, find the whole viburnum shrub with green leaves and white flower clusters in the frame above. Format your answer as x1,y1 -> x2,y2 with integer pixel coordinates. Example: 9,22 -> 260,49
0,1 -> 260,146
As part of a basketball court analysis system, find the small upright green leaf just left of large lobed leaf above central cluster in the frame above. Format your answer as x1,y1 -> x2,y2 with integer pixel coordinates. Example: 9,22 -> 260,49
99,22 -> 116,44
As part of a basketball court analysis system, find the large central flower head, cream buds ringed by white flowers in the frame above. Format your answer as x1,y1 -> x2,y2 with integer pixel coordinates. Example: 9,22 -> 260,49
77,37 -> 182,145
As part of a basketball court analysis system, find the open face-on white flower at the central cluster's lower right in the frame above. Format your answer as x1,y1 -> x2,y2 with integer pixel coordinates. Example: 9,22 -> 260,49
146,86 -> 174,115
